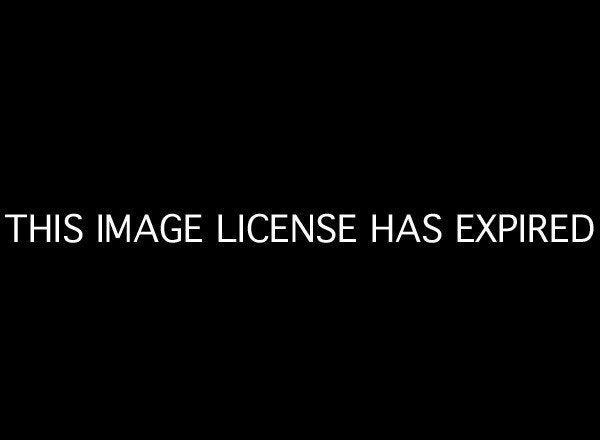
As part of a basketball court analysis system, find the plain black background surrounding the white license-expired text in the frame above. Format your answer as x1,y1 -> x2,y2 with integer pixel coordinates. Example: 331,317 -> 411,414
1,5 -> 598,433
